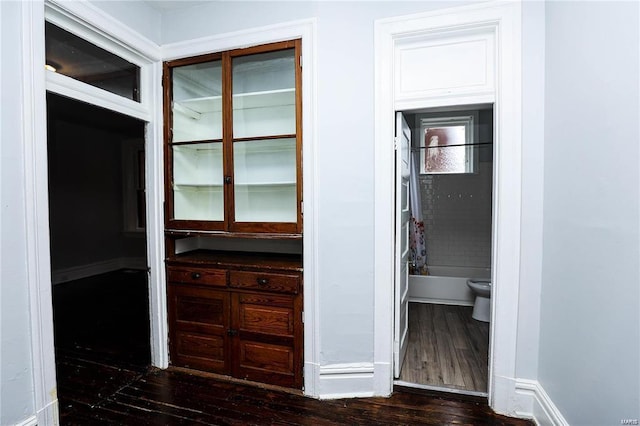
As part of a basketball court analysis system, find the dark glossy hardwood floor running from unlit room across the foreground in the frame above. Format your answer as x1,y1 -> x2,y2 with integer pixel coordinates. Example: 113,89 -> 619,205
54,273 -> 533,425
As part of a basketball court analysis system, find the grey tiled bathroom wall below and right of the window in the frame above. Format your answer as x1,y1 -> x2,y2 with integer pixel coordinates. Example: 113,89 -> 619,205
410,109 -> 493,268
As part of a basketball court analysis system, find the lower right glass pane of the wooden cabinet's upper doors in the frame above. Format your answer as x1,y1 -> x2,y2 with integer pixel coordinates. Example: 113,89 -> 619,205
233,138 -> 297,222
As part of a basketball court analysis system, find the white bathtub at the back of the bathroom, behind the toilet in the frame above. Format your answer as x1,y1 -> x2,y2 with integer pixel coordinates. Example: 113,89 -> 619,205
409,266 -> 491,306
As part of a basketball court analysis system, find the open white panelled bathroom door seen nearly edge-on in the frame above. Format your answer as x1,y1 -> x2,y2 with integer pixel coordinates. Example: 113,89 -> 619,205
393,112 -> 411,378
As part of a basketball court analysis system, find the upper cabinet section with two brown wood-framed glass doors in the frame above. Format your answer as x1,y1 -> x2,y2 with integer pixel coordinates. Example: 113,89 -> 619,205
164,41 -> 302,234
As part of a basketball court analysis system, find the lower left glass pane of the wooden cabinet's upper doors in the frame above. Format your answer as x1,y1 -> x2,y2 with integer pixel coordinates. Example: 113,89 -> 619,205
172,142 -> 224,221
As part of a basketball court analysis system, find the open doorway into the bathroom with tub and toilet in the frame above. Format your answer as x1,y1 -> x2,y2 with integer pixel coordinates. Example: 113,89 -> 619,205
394,104 -> 495,396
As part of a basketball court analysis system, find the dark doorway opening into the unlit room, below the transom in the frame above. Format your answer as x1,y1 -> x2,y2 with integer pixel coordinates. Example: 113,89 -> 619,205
47,93 -> 151,418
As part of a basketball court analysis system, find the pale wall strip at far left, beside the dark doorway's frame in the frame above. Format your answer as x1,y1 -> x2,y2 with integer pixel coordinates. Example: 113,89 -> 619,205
0,2 -> 35,425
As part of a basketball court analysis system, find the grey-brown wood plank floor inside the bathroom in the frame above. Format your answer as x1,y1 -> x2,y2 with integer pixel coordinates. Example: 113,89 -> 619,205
400,303 -> 489,392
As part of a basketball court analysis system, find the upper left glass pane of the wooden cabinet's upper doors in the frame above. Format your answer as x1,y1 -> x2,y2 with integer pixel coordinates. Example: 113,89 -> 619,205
172,60 -> 222,142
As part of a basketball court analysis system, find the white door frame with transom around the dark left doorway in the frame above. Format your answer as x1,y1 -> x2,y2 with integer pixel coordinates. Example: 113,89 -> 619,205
22,0 -> 168,425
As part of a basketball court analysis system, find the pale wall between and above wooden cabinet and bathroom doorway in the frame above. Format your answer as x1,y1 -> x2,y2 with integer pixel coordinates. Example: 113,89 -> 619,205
157,1 -> 476,365
